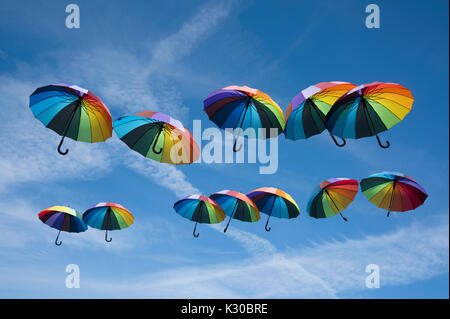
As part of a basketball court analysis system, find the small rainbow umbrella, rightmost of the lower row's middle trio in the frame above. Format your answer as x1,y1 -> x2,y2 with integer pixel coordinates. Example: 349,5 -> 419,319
247,187 -> 300,231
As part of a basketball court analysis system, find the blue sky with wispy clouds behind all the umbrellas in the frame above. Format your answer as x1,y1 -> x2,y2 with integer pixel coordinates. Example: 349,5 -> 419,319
0,0 -> 449,298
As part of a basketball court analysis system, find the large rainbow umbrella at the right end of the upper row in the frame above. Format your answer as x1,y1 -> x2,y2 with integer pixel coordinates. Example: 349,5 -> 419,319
326,82 -> 414,148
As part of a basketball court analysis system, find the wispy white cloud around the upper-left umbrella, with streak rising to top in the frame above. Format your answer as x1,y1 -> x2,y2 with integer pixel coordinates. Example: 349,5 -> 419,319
0,3 -> 236,195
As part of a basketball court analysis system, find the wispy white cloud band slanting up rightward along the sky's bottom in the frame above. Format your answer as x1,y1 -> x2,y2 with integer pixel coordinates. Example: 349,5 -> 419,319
7,218 -> 442,298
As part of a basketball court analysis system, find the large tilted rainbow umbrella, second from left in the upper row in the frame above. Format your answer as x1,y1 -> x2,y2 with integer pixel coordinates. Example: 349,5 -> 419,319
113,111 -> 200,165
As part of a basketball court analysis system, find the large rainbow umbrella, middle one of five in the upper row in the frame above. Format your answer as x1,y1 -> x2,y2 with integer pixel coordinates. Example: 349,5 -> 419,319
203,85 -> 284,152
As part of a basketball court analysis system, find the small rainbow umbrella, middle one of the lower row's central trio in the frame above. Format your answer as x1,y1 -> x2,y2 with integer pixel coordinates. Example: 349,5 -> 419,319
209,190 -> 260,233
